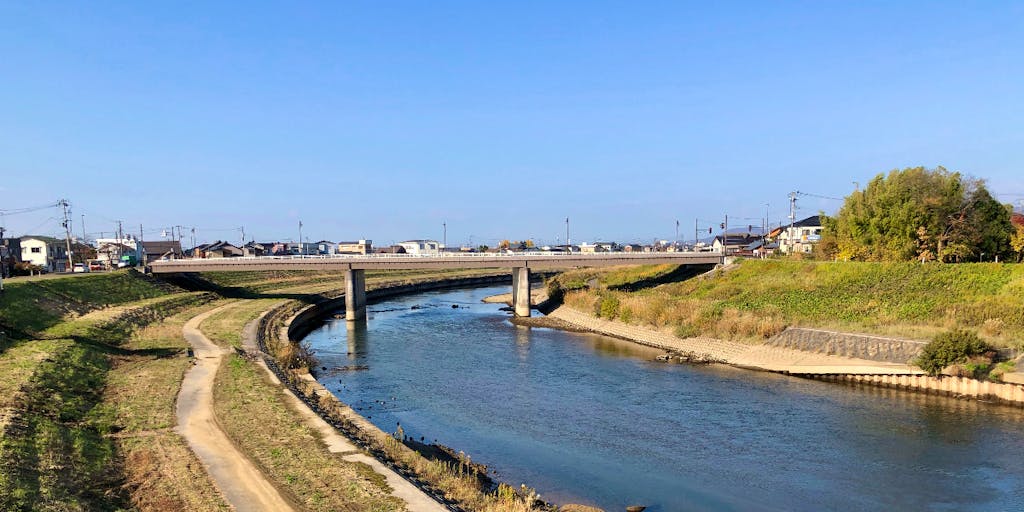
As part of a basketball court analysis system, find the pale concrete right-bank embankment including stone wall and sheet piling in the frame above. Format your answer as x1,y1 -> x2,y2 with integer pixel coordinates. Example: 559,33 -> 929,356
548,305 -> 1024,407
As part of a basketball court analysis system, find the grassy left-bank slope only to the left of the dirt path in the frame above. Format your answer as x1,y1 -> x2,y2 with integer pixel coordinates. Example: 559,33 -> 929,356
0,271 -> 223,510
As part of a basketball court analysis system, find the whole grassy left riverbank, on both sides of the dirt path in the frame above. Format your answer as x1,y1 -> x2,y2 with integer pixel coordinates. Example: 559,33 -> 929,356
0,270 -> 552,511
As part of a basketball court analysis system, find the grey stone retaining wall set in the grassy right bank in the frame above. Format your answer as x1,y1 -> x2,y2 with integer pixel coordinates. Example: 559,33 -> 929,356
766,327 -> 927,365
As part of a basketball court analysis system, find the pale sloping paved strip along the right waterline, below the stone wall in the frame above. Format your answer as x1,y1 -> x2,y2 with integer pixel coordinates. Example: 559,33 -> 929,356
548,305 -> 924,375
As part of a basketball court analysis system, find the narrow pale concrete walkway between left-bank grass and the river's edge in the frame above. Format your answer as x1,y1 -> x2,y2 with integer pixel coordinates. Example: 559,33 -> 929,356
242,304 -> 449,512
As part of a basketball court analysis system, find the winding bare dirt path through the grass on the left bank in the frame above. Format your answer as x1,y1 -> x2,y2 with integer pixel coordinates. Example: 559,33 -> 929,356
175,304 -> 295,512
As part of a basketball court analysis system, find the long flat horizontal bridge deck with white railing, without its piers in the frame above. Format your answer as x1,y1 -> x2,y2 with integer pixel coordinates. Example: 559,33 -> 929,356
150,252 -> 722,273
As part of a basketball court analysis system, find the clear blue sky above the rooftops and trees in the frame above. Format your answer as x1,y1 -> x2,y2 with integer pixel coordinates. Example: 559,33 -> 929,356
0,0 -> 1024,245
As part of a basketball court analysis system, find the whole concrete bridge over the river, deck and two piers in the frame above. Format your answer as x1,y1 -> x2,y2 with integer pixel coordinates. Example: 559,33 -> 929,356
150,252 -> 724,322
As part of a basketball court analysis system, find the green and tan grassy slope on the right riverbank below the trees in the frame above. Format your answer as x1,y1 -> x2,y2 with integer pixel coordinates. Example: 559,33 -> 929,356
555,260 -> 1024,348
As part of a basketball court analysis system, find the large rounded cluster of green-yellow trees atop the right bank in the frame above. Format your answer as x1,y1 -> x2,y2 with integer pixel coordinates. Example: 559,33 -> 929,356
821,167 -> 1014,262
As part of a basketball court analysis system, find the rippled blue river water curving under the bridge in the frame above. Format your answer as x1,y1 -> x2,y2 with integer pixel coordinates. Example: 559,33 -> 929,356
306,287 -> 1024,512
